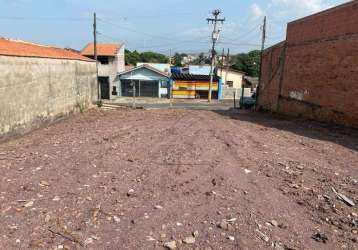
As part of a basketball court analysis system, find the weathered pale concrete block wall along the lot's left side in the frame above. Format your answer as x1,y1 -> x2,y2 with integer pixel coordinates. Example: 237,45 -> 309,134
0,56 -> 97,139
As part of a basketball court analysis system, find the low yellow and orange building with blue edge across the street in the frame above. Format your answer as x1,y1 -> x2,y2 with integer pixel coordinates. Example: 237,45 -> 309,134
171,73 -> 221,99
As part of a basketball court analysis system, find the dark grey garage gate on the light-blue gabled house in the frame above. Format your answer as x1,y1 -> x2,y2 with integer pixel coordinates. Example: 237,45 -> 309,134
121,80 -> 159,97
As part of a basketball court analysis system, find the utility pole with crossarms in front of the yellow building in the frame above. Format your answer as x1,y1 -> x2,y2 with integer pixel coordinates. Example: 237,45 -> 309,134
206,10 -> 225,102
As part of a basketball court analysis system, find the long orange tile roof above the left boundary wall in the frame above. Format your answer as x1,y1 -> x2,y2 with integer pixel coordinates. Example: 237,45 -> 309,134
0,38 -> 93,62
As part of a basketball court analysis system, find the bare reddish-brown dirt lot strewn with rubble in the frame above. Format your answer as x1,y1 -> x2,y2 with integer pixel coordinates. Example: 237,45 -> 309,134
0,110 -> 358,250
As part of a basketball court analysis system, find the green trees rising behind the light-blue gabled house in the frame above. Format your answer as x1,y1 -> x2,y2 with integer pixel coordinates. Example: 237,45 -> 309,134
125,50 -> 169,65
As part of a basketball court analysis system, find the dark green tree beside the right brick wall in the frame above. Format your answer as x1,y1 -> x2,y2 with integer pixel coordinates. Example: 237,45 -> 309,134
231,50 -> 260,77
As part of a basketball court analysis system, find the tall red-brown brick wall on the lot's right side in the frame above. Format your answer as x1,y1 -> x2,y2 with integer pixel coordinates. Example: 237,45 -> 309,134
259,1 -> 358,127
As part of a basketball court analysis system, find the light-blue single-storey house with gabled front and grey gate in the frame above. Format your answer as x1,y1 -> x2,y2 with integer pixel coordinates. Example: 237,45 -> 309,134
118,64 -> 170,98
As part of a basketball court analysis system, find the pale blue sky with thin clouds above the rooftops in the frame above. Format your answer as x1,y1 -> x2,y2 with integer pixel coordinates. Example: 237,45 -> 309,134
0,0 -> 347,54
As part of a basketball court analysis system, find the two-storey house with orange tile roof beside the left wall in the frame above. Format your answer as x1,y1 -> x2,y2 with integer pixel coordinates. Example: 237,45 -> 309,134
81,43 -> 125,99
